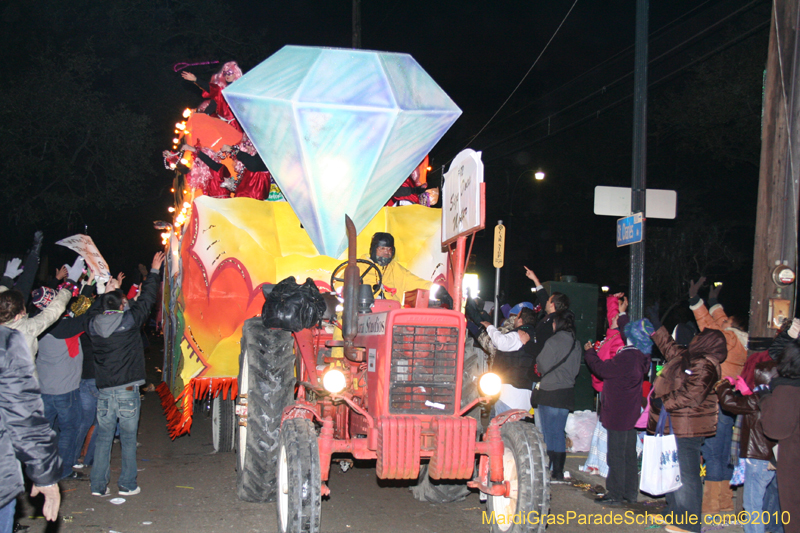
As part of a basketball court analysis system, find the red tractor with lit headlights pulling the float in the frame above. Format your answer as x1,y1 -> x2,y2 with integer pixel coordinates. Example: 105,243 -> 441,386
231,218 -> 550,533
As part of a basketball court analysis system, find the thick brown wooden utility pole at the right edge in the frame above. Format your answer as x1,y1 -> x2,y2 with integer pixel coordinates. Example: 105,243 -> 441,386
748,0 -> 800,351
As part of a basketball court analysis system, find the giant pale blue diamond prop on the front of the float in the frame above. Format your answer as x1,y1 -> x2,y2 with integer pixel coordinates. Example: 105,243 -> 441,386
223,46 -> 461,257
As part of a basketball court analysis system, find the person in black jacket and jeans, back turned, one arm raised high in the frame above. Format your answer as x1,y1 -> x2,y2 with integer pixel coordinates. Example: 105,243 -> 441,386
87,252 -> 164,496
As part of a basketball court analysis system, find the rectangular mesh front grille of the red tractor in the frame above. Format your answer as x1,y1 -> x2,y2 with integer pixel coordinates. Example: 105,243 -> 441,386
389,326 -> 458,414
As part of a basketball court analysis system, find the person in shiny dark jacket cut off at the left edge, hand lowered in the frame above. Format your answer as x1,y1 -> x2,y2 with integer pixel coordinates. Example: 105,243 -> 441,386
0,326 -> 61,531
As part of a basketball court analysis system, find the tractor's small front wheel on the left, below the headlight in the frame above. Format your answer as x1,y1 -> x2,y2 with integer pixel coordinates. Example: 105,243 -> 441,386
276,418 -> 322,533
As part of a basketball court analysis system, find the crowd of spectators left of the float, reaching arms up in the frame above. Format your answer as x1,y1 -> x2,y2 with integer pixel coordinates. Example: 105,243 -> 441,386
0,232 -> 164,533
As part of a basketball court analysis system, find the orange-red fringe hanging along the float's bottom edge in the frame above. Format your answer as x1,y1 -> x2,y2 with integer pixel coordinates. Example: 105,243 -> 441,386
156,378 -> 239,440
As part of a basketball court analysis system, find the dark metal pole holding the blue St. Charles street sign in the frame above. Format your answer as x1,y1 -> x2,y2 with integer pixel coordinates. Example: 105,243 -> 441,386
629,0 -> 650,320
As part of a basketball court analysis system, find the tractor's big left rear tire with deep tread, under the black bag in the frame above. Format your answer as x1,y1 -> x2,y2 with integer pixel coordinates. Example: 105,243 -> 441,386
236,317 -> 295,502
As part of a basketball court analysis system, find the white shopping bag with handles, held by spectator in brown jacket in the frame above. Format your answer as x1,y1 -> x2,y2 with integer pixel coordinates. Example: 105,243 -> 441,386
639,407 -> 682,496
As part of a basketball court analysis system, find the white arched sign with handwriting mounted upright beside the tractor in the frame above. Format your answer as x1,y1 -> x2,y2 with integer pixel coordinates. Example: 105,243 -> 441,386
442,148 -> 484,245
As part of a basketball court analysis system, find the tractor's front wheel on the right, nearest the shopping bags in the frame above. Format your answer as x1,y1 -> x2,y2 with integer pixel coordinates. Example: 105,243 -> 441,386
488,422 -> 550,533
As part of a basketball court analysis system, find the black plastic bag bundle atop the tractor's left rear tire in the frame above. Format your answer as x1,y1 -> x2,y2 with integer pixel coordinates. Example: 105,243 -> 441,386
261,276 -> 326,332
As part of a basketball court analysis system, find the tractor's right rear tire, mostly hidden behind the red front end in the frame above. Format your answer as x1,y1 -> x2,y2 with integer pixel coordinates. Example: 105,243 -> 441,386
411,337 -> 486,503
